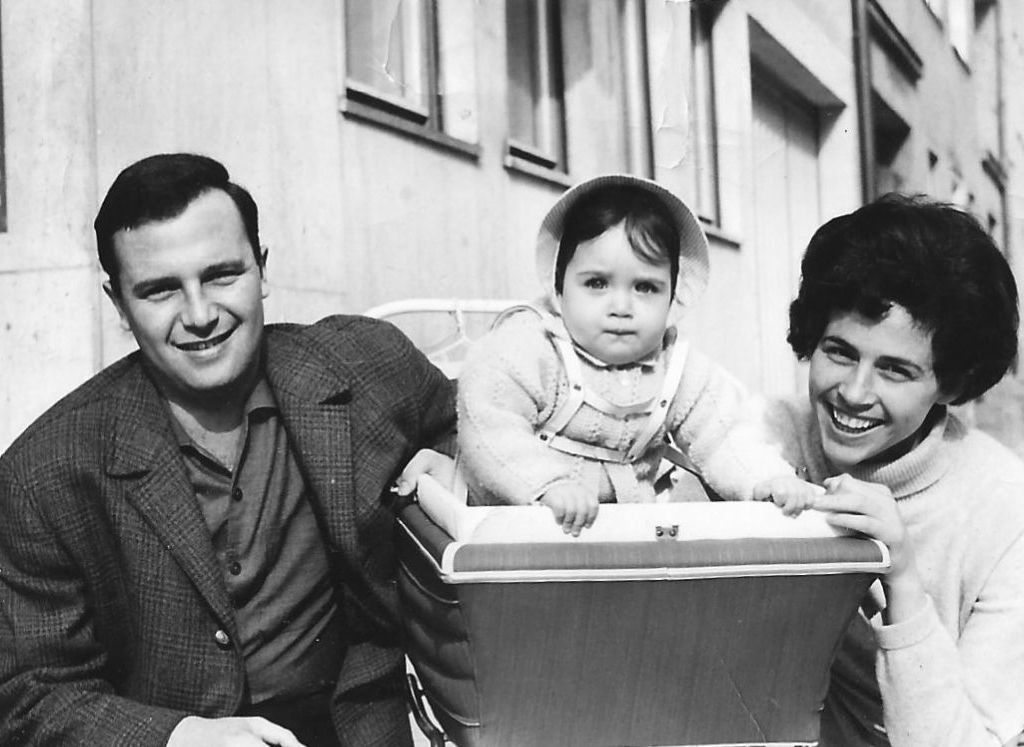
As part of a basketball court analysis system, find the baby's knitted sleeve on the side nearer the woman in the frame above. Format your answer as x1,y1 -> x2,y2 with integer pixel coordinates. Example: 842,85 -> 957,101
672,347 -> 796,500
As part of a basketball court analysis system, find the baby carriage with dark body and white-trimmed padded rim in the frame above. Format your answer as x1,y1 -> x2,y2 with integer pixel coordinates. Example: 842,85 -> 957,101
366,299 -> 889,747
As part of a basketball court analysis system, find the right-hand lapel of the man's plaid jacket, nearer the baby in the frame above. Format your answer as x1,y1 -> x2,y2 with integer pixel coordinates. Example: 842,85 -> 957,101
265,334 -> 358,559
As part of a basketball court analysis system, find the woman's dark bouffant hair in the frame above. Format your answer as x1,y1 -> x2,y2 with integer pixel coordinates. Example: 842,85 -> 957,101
786,195 -> 1019,405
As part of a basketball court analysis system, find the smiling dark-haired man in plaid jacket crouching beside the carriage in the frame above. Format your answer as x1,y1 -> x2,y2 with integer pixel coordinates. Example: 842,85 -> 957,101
0,154 -> 455,747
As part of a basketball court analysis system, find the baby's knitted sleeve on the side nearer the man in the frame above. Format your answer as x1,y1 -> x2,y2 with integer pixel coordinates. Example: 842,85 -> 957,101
459,313 -> 583,504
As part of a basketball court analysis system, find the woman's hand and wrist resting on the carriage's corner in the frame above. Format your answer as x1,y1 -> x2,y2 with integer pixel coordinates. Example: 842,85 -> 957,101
813,474 -> 926,625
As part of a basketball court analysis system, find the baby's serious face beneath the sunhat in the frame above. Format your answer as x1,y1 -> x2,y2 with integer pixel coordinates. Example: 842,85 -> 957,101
560,223 -> 672,366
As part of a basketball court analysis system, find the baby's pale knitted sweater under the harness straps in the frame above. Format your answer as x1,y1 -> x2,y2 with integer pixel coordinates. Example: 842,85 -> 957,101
459,312 -> 793,503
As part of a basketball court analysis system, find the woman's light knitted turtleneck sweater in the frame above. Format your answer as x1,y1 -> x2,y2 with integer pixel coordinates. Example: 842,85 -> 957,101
766,400 -> 1024,747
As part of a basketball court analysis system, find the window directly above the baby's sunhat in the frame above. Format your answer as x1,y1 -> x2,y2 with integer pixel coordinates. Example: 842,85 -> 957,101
506,0 -> 652,179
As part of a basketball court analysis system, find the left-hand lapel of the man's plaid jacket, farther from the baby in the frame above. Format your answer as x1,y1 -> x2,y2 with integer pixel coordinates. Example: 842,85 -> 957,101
103,366 -> 234,634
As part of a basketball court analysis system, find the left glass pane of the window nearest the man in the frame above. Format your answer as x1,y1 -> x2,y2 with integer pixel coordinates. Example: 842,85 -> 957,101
345,0 -> 430,110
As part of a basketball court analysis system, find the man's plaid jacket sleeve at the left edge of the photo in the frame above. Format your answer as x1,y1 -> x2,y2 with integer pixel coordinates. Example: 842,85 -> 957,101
0,463 -> 186,747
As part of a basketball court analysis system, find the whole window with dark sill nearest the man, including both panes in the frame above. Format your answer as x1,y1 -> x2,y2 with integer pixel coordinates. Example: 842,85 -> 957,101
344,0 -> 478,152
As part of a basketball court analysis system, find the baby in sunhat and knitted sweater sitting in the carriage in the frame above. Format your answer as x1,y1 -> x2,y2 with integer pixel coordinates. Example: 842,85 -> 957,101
459,174 -> 815,535
